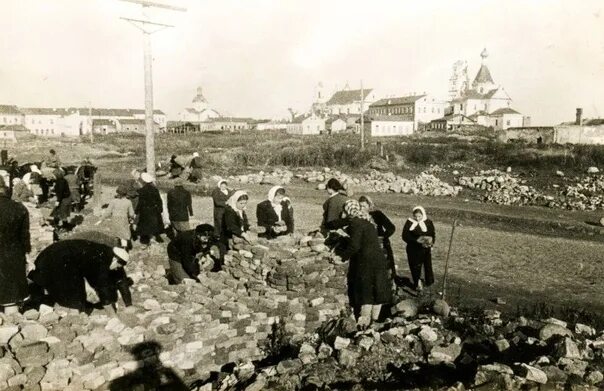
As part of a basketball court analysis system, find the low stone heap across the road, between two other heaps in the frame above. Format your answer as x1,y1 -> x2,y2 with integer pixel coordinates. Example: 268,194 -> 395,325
457,170 -> 554,206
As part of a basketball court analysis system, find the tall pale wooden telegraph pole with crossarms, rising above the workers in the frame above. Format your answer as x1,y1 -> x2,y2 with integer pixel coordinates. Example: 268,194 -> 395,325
121,0 -> 187,176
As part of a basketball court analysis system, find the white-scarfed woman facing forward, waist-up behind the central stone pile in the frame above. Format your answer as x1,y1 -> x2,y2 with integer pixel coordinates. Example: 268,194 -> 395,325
256,186 -> 294,239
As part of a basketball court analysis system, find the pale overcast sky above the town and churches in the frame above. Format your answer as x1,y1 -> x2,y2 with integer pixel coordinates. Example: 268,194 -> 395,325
0,0 -> 604,124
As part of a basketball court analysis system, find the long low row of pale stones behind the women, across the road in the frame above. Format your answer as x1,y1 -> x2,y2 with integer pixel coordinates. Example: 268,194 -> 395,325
298,168 -> 461,197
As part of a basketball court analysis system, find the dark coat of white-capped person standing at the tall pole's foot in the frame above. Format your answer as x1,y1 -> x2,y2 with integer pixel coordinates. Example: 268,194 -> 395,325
134,183 -> 164,236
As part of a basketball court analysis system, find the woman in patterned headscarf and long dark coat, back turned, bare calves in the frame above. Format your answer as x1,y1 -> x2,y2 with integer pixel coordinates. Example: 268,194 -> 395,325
342,200 -> 392,328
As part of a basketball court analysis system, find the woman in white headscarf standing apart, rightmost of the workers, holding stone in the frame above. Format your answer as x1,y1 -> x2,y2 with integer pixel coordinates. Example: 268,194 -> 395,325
403,206 -> 436,291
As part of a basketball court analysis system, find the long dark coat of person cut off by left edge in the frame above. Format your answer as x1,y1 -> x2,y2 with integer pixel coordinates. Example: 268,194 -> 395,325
0,195 -> 31,304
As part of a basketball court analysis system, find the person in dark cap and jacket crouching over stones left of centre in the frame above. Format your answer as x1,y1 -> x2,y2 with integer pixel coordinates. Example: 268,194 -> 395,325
168,224 -> 221,284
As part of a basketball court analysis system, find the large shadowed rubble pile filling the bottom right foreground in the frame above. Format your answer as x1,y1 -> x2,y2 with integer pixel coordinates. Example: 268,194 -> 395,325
241,306 -> 604,390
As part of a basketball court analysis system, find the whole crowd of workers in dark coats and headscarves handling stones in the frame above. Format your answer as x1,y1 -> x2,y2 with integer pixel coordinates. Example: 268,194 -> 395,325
0,152 -> 435,328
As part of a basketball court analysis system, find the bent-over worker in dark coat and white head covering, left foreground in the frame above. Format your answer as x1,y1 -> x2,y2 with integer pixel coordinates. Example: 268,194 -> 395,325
29,239 -> 132,316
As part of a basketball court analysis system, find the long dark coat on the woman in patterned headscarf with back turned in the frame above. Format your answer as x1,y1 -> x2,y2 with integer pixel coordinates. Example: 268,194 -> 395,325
342,217 -> 392,308
